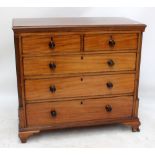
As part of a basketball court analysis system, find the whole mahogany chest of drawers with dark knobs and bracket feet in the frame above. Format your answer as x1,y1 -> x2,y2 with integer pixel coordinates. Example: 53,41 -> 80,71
13,18 -> 146,142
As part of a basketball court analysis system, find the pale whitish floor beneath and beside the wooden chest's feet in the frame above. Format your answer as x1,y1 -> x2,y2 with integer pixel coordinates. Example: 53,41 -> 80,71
0,92 -> 155,147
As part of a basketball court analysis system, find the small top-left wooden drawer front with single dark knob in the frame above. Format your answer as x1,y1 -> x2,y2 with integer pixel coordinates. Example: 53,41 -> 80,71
22,35 -> 80,54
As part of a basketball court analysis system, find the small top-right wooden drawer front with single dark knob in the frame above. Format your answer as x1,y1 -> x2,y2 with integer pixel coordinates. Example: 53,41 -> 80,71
84,34 -> 138,51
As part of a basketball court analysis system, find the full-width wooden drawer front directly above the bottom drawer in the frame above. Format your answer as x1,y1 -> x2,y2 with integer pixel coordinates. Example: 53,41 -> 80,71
25,74 -> 135,100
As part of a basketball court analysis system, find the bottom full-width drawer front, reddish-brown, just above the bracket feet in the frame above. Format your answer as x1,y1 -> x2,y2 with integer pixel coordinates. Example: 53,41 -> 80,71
26,96 -> 133,127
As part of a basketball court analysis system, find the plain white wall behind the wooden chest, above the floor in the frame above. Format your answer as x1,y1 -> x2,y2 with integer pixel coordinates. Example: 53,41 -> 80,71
0,7 -> 155,104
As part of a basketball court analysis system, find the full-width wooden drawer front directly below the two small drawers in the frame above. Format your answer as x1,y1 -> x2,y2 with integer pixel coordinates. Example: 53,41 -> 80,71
24,53 -> 136,76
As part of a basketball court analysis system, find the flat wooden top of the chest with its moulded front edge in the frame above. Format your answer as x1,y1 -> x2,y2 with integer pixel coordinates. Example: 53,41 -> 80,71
12,17 -> 146,31
